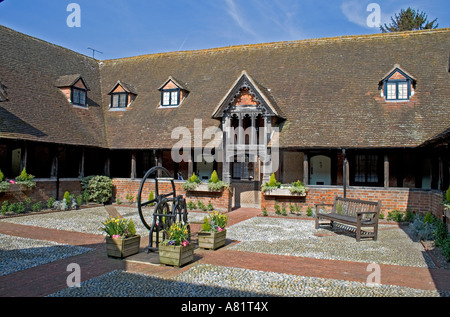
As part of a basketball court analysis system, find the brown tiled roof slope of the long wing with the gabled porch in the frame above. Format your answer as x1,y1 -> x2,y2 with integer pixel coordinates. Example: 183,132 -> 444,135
101,29 -> 450,148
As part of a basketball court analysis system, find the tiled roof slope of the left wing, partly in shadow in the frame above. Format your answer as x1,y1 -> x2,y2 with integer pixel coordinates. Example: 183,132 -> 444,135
0,26 -> 106,147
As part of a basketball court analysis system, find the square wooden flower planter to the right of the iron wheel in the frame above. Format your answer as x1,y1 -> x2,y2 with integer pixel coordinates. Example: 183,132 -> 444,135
198,211 -> 228,250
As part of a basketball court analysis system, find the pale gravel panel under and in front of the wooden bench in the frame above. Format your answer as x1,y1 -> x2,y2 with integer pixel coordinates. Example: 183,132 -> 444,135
227,217 -> 435,268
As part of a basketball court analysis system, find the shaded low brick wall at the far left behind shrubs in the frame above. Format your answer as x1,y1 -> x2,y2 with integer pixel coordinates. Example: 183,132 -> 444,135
0,178 -> 81,203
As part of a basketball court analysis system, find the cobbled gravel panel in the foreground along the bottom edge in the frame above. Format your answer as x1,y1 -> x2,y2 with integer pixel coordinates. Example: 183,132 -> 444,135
50,264 -> 449,297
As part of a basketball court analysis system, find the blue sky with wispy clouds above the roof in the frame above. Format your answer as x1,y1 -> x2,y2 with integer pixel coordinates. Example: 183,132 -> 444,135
0,0 -> 450,59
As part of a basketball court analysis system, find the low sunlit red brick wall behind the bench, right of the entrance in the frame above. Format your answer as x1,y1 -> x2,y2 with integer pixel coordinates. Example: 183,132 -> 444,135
261,186 -> 443,218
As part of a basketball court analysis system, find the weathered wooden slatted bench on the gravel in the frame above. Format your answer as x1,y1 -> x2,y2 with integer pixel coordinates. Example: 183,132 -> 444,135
316,196 -> 381,242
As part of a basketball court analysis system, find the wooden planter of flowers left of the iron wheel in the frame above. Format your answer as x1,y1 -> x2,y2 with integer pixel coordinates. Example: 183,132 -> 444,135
100,217 -> 141,258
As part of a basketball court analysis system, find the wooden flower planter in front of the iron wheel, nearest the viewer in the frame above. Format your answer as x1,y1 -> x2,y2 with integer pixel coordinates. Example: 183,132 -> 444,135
159,222 -> 194,267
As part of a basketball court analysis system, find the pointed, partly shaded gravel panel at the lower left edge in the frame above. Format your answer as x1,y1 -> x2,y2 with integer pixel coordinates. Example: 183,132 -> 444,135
0,234 -> 92,276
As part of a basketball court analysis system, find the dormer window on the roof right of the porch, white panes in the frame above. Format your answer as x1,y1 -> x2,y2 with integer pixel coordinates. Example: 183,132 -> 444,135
380,65 -> 416,101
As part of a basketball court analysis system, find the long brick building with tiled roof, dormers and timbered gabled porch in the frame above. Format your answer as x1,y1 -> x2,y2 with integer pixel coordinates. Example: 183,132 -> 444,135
0,27 -> 450,214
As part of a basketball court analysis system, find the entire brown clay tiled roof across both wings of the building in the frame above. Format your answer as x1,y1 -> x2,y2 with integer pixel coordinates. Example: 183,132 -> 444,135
0,23 -> 450,149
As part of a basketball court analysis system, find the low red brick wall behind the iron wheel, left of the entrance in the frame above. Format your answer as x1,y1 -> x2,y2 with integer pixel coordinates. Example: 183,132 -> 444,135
113,178 -> 232,212
